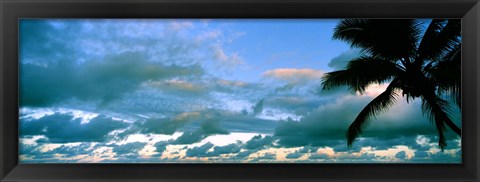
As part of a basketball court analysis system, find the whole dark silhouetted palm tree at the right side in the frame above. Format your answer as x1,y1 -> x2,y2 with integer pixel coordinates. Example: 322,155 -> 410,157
322,19 -> 461,150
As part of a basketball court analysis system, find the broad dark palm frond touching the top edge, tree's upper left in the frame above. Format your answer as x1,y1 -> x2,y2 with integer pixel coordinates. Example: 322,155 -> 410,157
333,19 -> 420,59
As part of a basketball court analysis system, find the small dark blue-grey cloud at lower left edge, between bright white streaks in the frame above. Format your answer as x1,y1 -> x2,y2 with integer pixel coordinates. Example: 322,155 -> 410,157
19,113 -> 128,143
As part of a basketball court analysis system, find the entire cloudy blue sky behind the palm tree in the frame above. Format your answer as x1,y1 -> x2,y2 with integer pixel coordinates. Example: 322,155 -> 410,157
19,19 -> 461,163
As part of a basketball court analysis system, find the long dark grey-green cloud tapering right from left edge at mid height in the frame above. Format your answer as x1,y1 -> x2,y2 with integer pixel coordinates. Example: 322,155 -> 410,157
20,52 -> 202,106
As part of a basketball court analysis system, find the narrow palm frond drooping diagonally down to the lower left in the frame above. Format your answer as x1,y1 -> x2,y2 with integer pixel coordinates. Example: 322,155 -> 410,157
346,79 -> 399,147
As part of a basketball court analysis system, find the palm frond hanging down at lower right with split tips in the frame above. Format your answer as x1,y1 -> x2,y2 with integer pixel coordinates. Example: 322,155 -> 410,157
422,91 -> 461,151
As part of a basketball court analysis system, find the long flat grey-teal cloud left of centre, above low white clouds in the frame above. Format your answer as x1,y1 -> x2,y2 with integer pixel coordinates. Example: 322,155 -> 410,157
115,109 -> 277,144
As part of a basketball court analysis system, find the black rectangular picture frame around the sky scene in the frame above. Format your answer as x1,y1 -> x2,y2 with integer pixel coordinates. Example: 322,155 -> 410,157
0,0 -> 480,182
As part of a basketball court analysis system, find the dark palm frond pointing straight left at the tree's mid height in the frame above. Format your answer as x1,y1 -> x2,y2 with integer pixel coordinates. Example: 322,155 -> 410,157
322,56 -> 402,93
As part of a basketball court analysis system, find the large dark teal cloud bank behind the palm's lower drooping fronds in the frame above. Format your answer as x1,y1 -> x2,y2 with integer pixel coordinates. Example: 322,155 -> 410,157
275,92 -> 460,150
